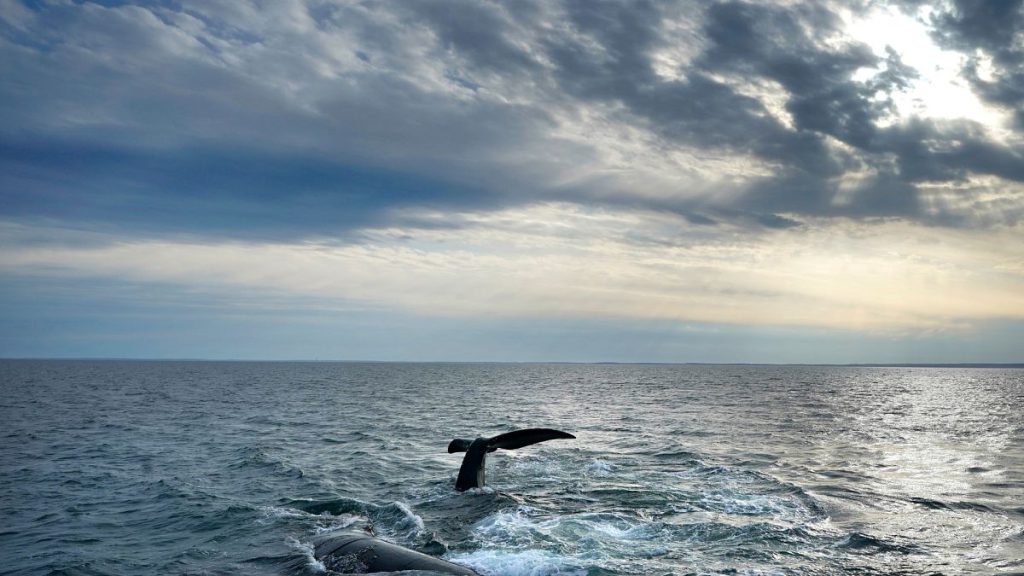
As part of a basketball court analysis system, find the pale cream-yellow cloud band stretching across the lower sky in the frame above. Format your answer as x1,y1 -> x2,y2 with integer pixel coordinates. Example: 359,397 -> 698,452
0,204 -> 1024,332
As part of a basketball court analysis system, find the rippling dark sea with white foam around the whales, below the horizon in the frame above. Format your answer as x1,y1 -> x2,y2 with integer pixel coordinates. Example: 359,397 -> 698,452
0,361 -> 1024,576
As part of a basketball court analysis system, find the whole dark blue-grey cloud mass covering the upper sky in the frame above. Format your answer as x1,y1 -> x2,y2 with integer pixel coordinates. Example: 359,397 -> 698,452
0,0 -> 1024,237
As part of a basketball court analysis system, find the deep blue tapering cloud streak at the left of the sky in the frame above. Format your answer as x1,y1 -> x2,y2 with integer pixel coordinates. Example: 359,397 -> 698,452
0,136 -> 491,240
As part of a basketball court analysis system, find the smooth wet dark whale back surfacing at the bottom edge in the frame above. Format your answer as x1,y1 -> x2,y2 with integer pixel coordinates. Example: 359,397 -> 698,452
313,532 -> 480,576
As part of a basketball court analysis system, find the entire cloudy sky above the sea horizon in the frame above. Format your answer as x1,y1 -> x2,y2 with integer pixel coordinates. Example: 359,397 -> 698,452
0,0 -> 1024,363
